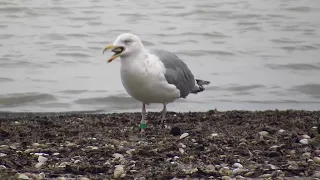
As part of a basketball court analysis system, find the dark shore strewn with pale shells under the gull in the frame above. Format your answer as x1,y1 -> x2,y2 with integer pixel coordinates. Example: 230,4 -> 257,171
0,111 -> 320,180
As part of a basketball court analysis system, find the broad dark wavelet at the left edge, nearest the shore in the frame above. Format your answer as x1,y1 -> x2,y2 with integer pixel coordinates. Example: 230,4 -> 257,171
0,92 -> 56,107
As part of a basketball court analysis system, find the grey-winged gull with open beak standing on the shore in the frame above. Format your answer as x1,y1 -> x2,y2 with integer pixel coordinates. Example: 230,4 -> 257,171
103,33 -> 210,132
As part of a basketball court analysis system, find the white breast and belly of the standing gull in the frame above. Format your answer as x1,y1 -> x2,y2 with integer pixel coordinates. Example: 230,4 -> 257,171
120,53 -> 180,104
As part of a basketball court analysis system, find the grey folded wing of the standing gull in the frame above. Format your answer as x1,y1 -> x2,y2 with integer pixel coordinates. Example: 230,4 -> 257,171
150,49 -> 195,98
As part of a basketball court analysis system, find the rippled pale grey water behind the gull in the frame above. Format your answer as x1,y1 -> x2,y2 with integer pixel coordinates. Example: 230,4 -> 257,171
0,0 -> 320,112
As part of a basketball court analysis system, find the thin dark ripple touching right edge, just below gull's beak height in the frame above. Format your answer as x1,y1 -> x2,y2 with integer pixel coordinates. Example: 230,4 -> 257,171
266,63 -> 320,70
